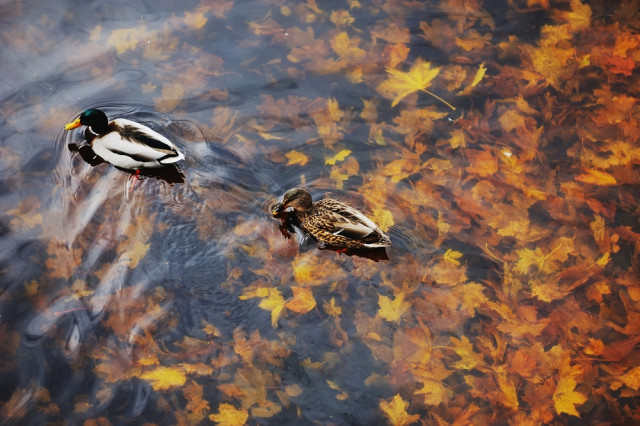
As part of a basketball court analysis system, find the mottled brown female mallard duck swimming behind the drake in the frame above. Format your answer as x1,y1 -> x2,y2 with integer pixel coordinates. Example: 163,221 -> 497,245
271,188 -> 391,249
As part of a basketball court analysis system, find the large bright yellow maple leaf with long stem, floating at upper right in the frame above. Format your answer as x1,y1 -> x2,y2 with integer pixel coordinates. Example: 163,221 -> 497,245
376,58 -> 455,111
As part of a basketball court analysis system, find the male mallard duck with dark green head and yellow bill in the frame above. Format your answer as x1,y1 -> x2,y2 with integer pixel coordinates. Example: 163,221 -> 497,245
64,109 -> 184,170
